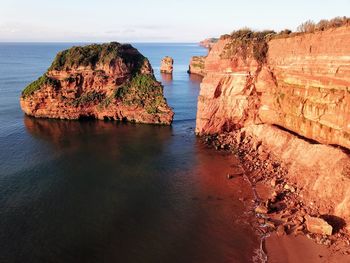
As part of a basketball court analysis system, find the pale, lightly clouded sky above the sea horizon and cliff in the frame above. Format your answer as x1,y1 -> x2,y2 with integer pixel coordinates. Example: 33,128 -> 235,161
0,0 -> 350,42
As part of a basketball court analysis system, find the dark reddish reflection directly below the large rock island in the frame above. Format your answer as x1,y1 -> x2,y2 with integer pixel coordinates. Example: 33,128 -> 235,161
24,116 -> 172,150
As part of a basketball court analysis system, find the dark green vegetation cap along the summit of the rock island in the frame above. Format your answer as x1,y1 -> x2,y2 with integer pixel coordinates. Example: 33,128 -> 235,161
48,42 -> 145,73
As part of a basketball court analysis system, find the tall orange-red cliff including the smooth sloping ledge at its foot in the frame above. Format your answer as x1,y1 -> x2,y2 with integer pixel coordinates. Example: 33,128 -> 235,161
196,26 -> 350,227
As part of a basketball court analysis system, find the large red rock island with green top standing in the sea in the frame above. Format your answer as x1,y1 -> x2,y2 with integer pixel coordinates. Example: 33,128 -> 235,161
20,42 -> 174,124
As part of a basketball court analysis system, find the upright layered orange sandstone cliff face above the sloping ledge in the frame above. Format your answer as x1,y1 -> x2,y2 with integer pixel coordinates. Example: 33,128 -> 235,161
196,27 -> 350,149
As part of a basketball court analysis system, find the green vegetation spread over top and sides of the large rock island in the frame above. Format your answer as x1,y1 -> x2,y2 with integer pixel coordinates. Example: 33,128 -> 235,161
22,42 -> 167,117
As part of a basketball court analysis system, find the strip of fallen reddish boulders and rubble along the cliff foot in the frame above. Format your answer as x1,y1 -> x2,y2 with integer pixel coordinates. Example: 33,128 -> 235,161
201,131 -> 350,255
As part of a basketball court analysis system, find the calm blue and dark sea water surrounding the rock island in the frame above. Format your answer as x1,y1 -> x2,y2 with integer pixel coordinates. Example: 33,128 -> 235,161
0,43 -> 259,263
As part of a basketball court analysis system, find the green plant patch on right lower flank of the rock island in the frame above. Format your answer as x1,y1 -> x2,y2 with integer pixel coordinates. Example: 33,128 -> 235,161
114,74 -> 166,114
